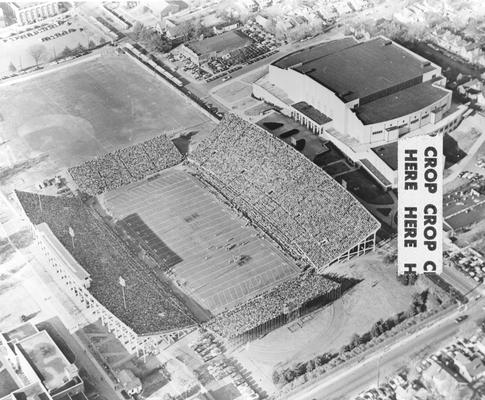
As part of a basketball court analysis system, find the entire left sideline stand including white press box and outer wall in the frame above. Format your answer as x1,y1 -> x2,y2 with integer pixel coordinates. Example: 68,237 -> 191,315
16,191 -> 198,350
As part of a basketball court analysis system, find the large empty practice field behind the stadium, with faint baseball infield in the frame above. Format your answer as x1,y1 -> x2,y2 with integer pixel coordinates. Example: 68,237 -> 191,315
0,56 -> 212,188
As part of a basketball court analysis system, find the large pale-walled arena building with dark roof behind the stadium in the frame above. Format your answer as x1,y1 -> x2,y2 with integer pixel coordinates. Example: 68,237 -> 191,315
253,37 -> 464,187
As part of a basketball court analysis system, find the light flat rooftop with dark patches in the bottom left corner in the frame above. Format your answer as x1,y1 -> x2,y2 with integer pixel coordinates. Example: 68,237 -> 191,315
19,331 -> 71,390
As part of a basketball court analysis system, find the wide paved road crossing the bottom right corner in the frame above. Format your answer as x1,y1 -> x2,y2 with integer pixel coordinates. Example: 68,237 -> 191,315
288,300 -> 485,400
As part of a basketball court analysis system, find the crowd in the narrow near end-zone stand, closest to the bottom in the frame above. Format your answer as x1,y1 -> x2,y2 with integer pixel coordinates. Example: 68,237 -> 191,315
206,274 -> 340,338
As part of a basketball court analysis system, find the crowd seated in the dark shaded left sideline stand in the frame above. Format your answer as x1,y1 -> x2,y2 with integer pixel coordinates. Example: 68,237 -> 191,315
16,191 -> 196,334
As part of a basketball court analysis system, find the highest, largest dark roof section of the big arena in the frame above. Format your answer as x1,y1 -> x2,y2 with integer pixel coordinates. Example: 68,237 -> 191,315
274,37 -> 435,102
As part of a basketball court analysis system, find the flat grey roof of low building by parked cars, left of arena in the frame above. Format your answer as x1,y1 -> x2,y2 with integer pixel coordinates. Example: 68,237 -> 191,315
185,30 -> 253,56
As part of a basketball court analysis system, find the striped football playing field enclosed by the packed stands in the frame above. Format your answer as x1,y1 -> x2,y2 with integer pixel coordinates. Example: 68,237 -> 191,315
104,168 -> 298,314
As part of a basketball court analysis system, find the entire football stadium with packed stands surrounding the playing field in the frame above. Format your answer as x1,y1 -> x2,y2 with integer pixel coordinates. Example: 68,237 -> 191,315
16,115 -> 380,353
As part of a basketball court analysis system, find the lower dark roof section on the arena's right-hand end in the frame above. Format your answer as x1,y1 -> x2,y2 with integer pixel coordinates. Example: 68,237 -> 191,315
356,81 -> 451,125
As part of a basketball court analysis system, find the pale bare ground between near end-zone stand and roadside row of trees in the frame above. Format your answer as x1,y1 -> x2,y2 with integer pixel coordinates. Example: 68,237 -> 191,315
233,253 -> 436,392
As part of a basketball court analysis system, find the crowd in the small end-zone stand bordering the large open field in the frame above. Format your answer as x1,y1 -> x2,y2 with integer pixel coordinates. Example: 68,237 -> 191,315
68,135 -> 182,196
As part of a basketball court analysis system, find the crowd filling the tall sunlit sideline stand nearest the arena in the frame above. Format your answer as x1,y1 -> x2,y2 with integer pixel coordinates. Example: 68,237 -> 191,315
189,115 -> 379,267
